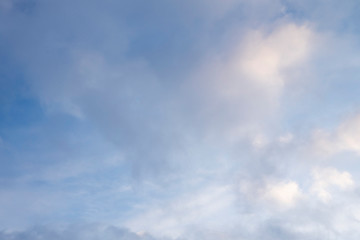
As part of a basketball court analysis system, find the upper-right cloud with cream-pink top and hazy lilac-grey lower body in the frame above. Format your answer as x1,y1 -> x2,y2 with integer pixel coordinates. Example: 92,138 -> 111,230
186,23 -> 316,142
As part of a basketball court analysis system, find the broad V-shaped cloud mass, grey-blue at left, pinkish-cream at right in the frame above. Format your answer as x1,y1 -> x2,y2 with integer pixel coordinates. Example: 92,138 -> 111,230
0,1 -> 313,182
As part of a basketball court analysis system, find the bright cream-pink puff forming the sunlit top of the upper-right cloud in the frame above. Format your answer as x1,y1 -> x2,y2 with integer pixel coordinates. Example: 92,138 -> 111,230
239,24 -> 313,90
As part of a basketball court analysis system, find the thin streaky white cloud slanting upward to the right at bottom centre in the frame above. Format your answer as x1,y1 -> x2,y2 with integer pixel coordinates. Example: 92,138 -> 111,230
125,185 -> 236,238
